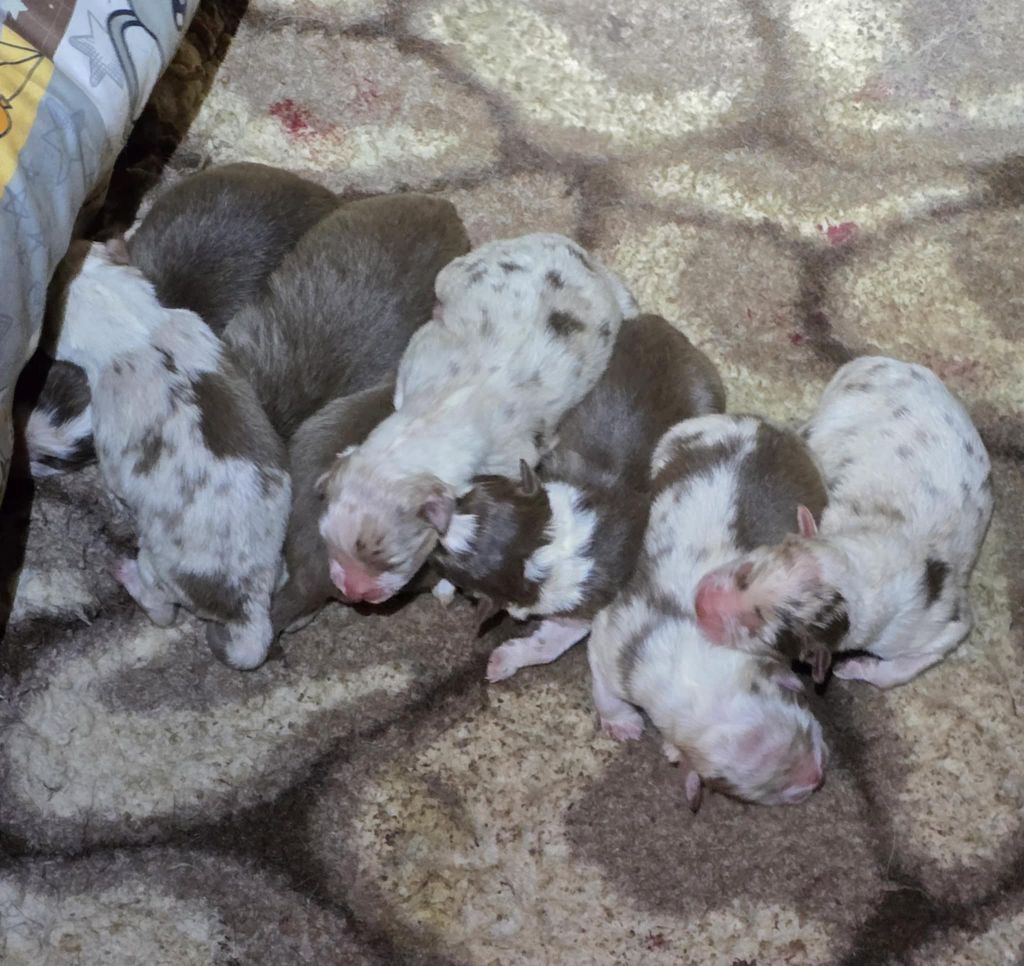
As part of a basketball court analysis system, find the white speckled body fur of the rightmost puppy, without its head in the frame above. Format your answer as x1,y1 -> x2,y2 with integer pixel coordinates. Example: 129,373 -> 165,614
808,356 -> 992,676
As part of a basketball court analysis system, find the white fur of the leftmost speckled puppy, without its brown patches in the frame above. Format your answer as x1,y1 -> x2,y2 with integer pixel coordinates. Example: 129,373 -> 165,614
57,246 -> 290,667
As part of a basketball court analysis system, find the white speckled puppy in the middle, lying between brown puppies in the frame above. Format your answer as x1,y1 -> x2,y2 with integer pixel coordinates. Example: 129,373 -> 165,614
321,235 -> 635,603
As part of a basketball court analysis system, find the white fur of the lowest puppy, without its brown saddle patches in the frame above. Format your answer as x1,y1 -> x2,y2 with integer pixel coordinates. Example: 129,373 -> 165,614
588,416 -> 826,803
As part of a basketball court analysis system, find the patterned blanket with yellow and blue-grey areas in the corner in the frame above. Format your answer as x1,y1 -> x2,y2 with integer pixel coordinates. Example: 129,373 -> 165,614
0,0 -> 199,496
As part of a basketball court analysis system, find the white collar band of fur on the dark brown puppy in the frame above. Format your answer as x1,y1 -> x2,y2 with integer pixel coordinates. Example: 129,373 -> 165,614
508,481 -> 597,621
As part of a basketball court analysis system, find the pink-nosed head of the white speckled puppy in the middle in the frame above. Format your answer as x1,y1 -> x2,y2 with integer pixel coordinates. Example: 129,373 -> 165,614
317,451 -> 455,603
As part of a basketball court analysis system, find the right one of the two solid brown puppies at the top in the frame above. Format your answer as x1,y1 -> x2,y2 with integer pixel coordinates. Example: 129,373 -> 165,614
224,195 -> 469,439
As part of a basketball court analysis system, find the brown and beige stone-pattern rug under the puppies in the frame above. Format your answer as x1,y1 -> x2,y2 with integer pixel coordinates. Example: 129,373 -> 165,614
0,0 -> 1024,966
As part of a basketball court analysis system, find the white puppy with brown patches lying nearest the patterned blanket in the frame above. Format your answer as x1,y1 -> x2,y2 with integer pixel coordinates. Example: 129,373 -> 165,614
57,244 -> 291,668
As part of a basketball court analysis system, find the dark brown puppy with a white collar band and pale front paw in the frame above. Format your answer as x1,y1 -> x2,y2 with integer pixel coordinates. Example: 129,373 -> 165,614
432,316 -> 725,681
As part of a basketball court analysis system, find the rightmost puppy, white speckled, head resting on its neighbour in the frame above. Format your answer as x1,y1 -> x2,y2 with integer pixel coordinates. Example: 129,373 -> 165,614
696,356 -> 992,687
